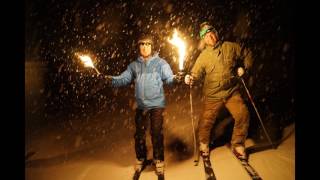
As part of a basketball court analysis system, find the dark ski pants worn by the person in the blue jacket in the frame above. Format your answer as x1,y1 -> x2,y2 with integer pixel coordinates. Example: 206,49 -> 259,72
134,108 -> 164,161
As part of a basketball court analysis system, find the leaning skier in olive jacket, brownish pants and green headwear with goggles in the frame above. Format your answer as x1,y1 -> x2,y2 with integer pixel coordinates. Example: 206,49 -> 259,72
185,22 -> 253,159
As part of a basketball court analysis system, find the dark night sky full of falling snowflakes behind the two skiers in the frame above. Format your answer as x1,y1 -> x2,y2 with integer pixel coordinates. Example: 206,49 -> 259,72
25,0 -> 295,125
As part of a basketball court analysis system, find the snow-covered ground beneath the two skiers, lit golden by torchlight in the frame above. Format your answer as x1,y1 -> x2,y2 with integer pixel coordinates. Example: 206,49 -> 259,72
25,89 -> 295,180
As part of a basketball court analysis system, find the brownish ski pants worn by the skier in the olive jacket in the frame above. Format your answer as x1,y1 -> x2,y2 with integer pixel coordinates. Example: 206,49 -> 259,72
198,92 -> 249,146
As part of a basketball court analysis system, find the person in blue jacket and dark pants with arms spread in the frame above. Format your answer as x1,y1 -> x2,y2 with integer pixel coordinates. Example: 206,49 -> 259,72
102,34 -> 183,177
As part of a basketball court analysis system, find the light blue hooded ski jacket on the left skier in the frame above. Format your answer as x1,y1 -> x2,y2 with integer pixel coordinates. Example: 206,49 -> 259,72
112,53 -> 174,109
